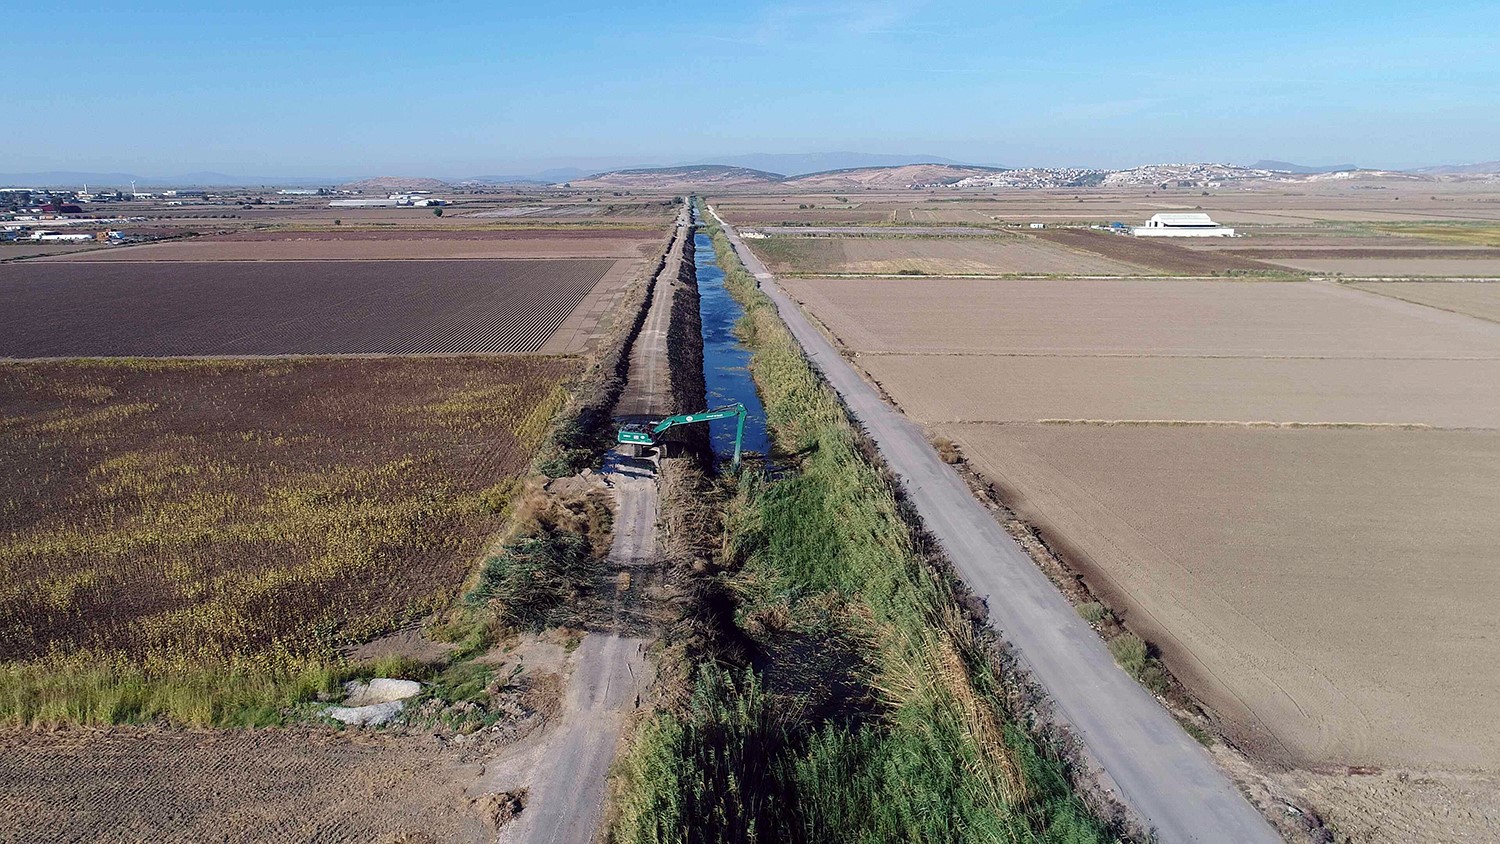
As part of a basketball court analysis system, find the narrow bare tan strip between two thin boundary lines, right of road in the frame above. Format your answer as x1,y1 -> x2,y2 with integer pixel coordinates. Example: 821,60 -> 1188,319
860,354 -> 1500,427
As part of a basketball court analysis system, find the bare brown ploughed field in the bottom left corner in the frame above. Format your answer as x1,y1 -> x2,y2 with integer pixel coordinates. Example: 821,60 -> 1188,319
0,729 -> 483,844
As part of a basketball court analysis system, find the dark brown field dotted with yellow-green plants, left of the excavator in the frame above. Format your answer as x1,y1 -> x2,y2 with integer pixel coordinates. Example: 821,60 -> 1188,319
0,357 -> 578,667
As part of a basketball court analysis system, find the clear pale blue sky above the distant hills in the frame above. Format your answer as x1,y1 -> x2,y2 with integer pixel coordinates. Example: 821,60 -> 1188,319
0,0 -> 1500,177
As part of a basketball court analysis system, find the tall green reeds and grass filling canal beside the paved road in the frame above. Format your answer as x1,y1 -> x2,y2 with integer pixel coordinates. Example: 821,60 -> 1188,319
615,208 -> 1110,843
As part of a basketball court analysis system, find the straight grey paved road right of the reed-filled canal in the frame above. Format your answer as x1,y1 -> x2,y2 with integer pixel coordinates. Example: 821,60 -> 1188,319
710,208 -> 1281,844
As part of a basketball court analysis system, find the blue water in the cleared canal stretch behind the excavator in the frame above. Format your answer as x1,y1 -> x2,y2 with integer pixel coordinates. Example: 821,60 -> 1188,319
693,227 -> 771,460
